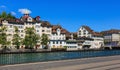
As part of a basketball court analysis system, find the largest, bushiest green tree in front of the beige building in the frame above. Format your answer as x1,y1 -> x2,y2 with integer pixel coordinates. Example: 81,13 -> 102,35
23,27 -> 40,49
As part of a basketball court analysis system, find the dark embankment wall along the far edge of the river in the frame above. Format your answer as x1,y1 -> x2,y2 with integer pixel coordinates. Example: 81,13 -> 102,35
0,47 -> 120,54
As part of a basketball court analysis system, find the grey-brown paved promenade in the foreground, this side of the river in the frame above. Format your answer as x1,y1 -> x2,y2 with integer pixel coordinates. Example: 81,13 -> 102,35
0,55 -> 120,70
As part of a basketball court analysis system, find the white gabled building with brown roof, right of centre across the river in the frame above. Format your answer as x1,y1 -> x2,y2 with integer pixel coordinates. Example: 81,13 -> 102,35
77,26 -> 104,49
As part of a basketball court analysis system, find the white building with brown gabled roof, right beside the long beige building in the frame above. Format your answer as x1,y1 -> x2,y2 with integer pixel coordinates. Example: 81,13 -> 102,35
49,25 -> 66,49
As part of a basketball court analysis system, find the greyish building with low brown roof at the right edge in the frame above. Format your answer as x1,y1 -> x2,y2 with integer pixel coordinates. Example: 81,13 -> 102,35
101,29 -> 120,47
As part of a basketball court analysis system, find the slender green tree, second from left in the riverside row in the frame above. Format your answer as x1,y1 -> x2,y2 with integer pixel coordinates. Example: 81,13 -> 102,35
12,26 -> 21,49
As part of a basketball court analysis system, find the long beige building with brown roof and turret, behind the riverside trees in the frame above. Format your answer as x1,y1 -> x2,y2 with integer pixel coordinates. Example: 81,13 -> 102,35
1,14 -> 52,48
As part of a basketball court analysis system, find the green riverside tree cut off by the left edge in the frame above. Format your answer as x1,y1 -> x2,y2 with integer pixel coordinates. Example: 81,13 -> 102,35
0,26 -> 10,49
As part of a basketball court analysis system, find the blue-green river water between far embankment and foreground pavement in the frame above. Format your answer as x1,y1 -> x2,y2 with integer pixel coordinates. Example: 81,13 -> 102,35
0,50 -> 120,65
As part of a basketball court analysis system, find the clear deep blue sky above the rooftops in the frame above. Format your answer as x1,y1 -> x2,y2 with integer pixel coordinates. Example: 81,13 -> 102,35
0,0 -> 120,32
